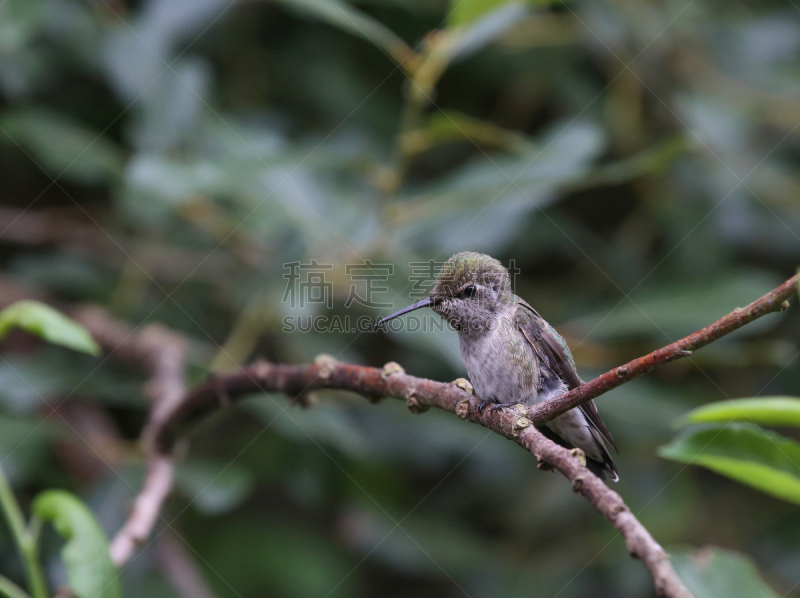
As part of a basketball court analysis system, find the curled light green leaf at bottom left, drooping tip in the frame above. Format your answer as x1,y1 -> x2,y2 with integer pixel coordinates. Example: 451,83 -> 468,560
32,490 -> 122,598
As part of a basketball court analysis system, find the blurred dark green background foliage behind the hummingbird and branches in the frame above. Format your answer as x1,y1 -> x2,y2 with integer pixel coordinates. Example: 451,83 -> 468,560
0,0 -> 800,598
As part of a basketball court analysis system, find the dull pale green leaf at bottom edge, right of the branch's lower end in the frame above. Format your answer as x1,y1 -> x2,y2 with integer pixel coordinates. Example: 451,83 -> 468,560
670,547 -> 778,598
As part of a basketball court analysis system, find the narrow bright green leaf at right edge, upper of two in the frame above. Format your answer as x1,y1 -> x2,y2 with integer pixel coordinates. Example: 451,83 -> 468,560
682,397 -> 800,427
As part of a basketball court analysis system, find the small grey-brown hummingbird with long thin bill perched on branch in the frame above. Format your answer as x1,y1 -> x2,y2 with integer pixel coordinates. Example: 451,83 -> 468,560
378,252 -> 619,482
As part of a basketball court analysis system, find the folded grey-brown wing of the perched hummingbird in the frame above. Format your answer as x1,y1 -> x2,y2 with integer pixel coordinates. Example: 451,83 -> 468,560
515,299 -> 619,451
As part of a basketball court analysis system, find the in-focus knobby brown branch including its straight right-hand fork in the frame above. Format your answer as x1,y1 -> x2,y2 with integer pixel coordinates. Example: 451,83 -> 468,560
141,276 -> 797,597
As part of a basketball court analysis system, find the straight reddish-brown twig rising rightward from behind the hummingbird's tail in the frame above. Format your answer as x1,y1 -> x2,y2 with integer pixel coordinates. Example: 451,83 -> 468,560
528,275 -> 798,423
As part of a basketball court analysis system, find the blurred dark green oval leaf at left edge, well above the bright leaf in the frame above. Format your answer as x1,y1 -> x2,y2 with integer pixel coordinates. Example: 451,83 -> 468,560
0,108 -> 124,183
